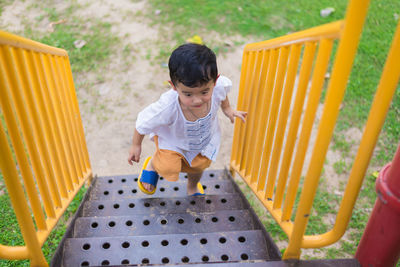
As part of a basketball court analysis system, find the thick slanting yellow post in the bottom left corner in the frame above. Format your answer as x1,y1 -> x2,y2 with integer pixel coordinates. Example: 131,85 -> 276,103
0,125 -> 48,266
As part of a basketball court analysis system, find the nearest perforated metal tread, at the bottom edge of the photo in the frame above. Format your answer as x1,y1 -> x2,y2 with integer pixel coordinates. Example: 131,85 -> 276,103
64,230 -> 268,266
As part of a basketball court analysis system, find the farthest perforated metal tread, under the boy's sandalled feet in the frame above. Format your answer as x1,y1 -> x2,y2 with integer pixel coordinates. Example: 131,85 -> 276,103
89,179 -> 235,200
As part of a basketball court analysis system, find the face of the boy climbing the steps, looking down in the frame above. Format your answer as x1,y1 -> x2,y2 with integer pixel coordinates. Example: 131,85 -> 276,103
171,81 -> 215,110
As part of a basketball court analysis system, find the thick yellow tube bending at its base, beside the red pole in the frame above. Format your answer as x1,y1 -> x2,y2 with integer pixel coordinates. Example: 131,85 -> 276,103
302,16 -> 400,248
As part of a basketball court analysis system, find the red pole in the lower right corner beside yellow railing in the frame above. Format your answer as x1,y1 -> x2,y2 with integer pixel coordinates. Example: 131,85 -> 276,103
355,143 -> 400,267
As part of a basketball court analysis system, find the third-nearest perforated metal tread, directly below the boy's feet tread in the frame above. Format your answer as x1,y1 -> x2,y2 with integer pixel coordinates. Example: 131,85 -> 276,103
82,194 -> 245,217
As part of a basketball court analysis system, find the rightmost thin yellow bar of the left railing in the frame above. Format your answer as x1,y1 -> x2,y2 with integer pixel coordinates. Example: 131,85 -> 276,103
63,57 -> 91,172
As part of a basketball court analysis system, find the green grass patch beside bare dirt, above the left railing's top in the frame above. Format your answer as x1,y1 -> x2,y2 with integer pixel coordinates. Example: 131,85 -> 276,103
19,2 -> 119,74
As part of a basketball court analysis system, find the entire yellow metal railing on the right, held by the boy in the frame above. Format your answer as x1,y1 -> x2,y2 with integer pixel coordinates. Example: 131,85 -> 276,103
230,0 -> 400,259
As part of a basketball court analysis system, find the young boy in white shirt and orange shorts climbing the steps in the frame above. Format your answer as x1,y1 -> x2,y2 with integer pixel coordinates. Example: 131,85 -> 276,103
128,43 -> 247,195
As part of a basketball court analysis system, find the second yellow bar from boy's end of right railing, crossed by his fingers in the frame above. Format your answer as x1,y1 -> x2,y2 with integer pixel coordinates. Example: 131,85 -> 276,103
236,52 -> 255,174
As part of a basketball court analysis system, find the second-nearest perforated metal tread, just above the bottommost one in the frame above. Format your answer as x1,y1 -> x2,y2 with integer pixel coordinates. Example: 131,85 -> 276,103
74,210 -> 255,237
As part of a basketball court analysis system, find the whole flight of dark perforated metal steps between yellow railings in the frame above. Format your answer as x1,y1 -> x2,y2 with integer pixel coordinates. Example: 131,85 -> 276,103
52,170 -> 280,266
